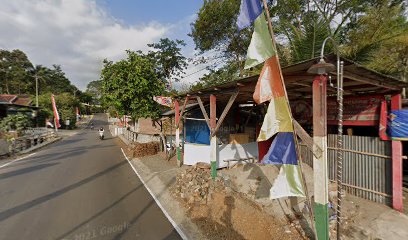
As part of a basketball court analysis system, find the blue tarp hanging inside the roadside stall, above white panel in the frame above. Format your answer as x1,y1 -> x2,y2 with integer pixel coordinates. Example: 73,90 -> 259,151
186,119 -> 210,145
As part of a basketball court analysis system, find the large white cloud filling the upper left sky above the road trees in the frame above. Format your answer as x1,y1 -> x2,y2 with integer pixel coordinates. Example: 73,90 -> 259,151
0,0 -> 171,89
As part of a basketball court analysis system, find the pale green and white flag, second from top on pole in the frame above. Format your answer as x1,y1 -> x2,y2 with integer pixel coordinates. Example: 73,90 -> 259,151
244,14 -> 276,69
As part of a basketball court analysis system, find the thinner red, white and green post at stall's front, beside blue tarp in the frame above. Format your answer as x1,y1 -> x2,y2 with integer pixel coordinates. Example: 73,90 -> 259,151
210,94 -> 217,179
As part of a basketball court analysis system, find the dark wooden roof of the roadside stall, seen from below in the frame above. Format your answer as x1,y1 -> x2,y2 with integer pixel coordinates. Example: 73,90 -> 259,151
178,54 -> 408,103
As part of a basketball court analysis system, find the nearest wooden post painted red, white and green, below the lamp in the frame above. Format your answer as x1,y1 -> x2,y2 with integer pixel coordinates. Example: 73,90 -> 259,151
313,75 -> 329,240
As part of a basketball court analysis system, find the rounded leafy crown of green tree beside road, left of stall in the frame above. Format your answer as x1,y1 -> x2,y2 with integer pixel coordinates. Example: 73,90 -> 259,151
101,50 -> 164,119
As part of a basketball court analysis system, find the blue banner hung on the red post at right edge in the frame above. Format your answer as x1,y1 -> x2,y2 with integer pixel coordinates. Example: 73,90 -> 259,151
388,109 -> 408,140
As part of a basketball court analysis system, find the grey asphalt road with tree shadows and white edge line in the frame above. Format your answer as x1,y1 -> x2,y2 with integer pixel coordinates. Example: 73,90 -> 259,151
0,115 -> 181,240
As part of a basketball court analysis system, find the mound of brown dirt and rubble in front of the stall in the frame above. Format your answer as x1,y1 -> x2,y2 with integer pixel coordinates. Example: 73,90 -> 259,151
172,163 -> 304,240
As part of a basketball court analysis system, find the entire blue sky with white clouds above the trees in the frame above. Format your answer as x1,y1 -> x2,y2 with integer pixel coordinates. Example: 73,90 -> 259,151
0,0 -> 204,90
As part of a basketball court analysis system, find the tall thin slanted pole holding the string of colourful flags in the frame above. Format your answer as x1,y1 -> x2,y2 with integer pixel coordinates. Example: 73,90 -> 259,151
263,0 -> 317,239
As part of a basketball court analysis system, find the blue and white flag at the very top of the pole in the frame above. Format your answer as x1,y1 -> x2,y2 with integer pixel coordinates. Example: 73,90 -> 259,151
237,0 -> 262,31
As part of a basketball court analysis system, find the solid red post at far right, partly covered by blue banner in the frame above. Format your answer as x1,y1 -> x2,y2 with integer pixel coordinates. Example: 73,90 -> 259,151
391,94 -> 403,212
